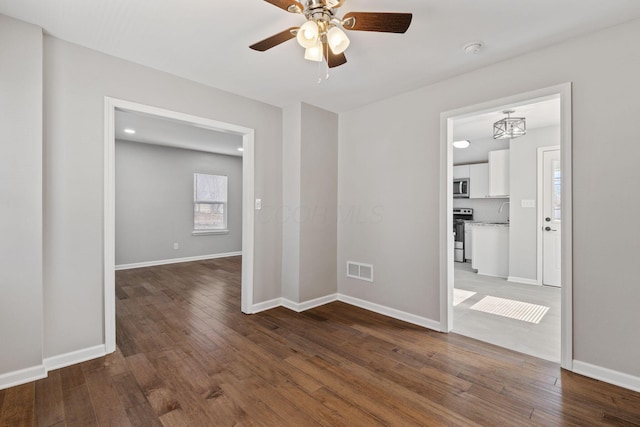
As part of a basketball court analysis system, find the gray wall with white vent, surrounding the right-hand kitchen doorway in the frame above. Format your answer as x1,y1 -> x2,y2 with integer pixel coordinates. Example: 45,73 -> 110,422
338,20 -> 640,376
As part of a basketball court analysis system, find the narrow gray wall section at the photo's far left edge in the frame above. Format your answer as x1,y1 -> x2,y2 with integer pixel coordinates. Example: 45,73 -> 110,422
0,15 -> 43,375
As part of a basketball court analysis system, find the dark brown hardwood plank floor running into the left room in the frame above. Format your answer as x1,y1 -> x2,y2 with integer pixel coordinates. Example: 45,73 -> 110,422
0,257 -> 640,426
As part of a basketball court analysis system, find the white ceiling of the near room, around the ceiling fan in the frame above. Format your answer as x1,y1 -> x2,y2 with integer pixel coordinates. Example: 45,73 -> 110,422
0,0 -> 640,112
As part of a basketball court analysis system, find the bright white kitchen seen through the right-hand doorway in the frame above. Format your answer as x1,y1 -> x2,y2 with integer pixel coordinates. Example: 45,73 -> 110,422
452,98 -> 561,361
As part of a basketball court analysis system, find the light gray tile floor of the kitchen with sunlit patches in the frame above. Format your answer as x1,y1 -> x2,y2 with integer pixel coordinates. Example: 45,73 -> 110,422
453,262 -> 560,362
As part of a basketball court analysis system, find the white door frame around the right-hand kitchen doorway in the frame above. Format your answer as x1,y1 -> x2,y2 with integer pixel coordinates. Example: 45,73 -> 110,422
440,82 -> 573,370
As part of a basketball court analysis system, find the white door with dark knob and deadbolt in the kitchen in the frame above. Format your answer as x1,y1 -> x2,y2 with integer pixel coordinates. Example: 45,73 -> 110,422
542,149 -> 562,286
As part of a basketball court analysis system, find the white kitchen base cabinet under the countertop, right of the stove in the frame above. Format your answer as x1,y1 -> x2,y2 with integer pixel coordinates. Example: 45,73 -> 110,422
471,224 -> 509,278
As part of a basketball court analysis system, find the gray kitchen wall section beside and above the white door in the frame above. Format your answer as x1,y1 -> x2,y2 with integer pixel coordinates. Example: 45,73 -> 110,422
509,126 -> 560,280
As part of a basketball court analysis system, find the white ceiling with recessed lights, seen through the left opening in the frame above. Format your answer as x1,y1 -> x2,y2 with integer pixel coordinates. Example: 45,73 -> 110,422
115,110 -> 242,156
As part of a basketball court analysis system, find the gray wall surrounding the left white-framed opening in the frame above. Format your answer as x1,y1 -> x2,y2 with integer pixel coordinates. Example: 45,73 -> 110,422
44,36 -> 282,356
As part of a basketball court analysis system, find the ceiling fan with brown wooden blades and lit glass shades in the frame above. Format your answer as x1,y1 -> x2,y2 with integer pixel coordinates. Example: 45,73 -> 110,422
249,0 -> 412,68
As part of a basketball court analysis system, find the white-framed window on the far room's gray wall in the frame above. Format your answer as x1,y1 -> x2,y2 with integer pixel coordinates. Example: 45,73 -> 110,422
193,173 -> 227,233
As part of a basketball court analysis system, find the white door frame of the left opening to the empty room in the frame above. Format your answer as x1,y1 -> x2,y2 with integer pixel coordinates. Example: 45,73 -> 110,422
103,96 -> 255,353
